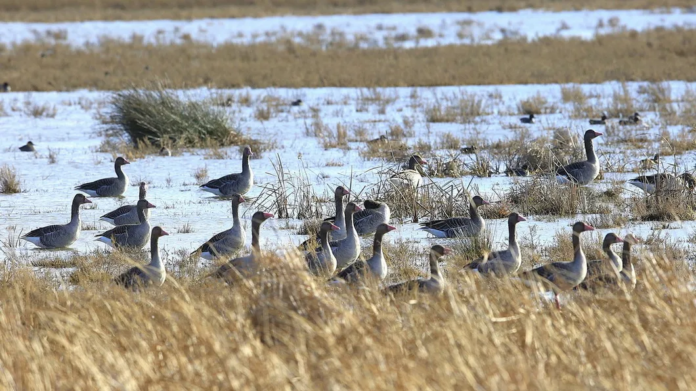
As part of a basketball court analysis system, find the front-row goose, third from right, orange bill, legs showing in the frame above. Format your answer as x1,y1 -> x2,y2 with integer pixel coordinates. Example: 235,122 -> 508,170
520,221 -> 594,308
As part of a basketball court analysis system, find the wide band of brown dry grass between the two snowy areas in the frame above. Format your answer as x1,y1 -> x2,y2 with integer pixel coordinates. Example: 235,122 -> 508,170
3,30 -> 696,91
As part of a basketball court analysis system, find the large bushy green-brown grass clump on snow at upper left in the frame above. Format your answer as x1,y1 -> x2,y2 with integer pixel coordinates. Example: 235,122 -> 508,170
106,83 -> 247,147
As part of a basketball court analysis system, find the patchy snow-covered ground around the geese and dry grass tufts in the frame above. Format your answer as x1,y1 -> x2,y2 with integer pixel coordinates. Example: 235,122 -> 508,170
0,82 -> 696,264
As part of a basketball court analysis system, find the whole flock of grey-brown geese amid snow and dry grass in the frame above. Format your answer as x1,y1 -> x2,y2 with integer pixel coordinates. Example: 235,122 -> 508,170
14,125 -> 680,303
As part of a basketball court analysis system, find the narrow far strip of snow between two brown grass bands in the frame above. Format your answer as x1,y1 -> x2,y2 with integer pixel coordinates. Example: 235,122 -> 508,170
0,10 -> 696,48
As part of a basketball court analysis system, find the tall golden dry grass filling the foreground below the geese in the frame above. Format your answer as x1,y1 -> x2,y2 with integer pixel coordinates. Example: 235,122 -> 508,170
0,248 -> 696,390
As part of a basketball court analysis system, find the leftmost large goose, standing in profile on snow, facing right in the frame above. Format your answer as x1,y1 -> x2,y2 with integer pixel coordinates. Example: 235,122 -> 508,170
22,194 -> 92,248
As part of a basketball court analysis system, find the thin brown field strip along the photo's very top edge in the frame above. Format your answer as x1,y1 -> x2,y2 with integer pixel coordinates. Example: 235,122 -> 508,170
0,0 -> 693,22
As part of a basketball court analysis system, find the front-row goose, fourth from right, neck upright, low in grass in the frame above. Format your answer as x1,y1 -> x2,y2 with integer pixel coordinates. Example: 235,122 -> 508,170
464,213 -> 527,276
